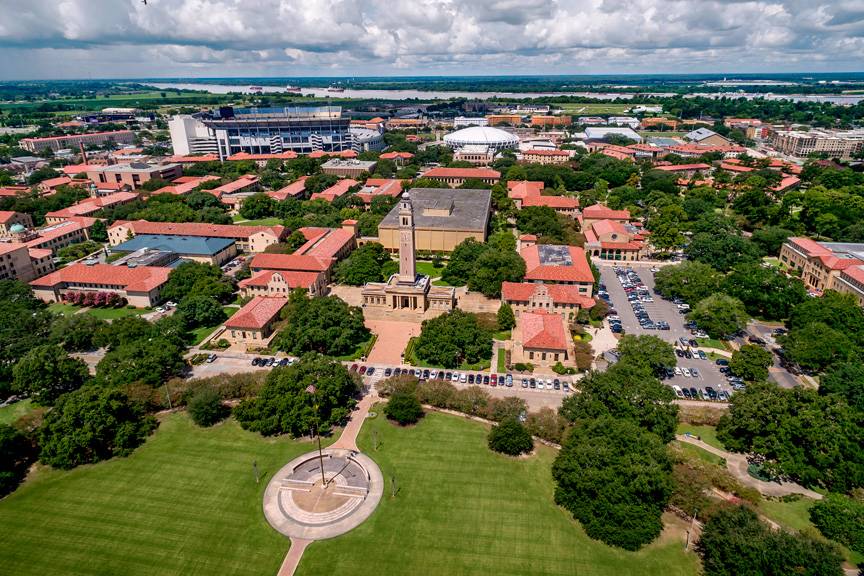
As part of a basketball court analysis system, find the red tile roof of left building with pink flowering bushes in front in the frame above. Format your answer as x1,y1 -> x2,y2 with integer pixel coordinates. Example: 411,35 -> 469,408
30,263 -> 171,292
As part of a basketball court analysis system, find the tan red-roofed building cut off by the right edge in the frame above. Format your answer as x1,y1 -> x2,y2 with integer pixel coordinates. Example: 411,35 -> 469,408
780,237 -> 864,294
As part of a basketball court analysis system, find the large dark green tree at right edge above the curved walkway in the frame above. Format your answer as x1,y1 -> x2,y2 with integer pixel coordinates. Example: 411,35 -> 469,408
717,382 -> 864,491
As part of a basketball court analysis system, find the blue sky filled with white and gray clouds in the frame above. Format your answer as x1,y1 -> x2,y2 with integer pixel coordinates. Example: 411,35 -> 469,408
0,0 -> 864,80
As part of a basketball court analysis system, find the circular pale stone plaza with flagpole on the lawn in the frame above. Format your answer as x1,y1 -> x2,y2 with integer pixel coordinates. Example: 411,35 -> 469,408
264,448 -> 384,540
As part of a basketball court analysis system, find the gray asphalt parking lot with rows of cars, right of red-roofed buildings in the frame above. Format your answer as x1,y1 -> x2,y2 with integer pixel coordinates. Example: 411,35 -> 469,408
600,262 -> 733,399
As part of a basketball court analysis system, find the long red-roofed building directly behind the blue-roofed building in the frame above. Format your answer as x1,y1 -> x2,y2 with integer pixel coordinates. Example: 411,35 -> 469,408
108,220 -> 288,252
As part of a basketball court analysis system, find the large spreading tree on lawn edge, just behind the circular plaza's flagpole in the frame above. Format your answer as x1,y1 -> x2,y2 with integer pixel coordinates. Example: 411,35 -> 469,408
234,353 -> 360,437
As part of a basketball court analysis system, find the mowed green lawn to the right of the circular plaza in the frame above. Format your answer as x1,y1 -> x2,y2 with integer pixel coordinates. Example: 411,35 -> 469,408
297,413 -> 699,576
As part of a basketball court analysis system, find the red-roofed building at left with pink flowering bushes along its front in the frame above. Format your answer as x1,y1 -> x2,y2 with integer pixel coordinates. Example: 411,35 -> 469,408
30,263 -> 171,308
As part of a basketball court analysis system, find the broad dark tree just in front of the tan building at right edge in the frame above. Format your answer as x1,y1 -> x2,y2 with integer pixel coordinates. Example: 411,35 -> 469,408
723,264 -> 807,320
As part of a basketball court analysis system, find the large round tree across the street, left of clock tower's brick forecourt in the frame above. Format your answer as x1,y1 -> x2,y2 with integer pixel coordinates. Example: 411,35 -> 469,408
274,290 -> 369,356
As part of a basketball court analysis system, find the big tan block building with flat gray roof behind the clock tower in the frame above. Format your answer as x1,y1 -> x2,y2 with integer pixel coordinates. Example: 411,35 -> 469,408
378,188 -> 492,252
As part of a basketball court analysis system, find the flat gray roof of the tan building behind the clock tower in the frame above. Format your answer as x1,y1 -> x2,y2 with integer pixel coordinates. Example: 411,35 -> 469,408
380,188 -> 492,232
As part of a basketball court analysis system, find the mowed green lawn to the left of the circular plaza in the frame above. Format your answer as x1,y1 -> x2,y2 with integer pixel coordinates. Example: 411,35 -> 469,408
0,413 -> 312,576
